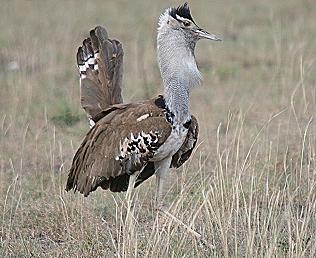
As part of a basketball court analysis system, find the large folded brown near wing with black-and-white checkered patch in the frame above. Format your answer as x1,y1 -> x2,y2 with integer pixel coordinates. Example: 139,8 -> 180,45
66,100 -> 171,196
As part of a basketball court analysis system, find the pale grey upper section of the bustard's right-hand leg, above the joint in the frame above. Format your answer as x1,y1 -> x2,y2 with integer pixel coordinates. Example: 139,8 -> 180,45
155,157 -> 171,210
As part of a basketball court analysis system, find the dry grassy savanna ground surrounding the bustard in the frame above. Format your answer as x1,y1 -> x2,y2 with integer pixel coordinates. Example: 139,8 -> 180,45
0,0 -> 316,257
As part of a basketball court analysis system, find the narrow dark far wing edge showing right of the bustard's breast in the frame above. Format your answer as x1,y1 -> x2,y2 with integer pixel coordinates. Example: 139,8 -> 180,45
171,116 -> 199,168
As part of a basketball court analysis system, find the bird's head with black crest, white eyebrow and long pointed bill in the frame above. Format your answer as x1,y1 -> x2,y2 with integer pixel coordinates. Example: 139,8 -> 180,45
158,3 -> 221,42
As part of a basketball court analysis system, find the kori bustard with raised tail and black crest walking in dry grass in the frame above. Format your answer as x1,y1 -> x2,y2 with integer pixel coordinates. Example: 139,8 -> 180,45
66,3 -> 220,209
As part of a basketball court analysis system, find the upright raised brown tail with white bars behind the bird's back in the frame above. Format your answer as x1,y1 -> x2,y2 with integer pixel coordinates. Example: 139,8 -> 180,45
77,26 -> 123,120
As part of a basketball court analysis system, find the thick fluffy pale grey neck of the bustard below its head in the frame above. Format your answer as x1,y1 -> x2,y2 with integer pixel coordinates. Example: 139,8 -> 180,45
157,30 -> 201,124
